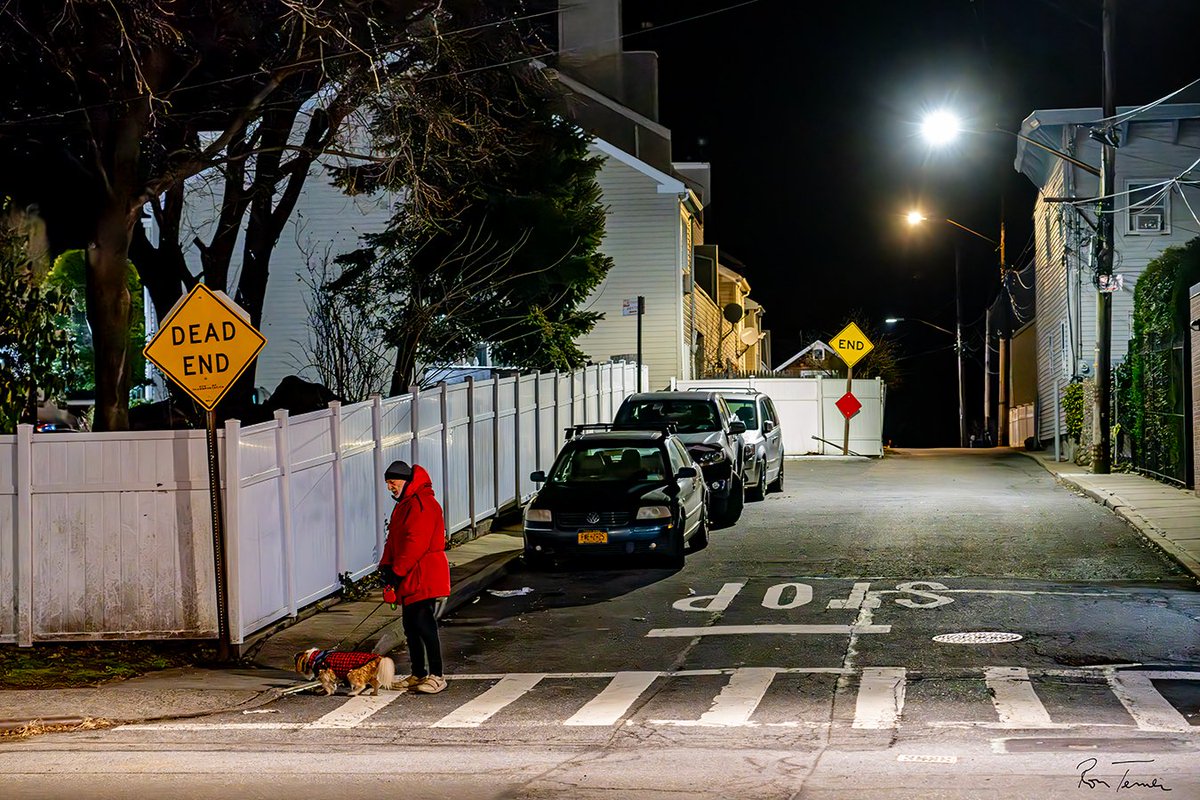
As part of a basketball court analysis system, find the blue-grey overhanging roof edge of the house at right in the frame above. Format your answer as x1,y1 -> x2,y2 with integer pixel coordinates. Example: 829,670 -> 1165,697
1013,103 -> 1200,188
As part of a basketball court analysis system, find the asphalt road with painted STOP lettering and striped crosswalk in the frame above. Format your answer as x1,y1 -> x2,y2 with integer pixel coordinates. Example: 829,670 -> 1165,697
0,451 -> 1200,800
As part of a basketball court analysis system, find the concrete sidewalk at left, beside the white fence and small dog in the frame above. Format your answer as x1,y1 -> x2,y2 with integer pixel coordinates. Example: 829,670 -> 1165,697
0,522 -> 522,741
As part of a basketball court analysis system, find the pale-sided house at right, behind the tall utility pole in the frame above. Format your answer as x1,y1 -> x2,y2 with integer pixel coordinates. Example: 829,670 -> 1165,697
1013,104 -> 1200,441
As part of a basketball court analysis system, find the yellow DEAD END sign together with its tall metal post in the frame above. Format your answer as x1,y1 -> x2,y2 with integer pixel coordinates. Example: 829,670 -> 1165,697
142,283 -> 266,661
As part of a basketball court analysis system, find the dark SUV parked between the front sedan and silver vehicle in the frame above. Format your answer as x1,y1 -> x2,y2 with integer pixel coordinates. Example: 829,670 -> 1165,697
613,391 -> 746,524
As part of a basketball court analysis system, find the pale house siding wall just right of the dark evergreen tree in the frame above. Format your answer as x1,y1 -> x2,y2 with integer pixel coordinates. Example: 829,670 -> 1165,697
578,152 -> 683,387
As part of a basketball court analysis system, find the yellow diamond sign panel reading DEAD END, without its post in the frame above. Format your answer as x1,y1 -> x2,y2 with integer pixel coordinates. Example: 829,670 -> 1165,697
142,283 -> 266,411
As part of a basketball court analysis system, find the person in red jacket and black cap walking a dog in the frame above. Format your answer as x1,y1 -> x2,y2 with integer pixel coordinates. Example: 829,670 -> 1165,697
379,461 -> 450,694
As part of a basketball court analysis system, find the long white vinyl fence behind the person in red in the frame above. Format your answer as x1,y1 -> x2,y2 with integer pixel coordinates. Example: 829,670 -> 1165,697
0,363 -> 637,645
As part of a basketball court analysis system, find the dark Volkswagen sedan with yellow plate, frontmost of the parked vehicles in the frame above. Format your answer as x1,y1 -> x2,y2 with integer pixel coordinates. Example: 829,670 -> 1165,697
524,431 -> 708,567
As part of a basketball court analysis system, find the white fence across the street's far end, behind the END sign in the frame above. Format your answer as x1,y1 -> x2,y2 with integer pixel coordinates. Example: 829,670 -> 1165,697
671,378 -> 887,456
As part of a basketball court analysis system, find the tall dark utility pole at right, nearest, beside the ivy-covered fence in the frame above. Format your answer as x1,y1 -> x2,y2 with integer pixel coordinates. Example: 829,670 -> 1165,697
1099,0 -> 1117,475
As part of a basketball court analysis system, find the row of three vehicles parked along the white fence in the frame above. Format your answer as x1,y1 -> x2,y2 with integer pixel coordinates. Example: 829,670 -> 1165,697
524,389 -> 784,569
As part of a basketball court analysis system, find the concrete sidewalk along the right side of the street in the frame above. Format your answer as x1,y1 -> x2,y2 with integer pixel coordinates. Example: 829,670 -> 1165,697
1024,452 -> 1200,579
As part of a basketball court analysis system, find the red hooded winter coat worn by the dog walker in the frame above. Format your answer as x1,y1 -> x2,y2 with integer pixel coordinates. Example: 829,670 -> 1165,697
379,464 -> 450,604
